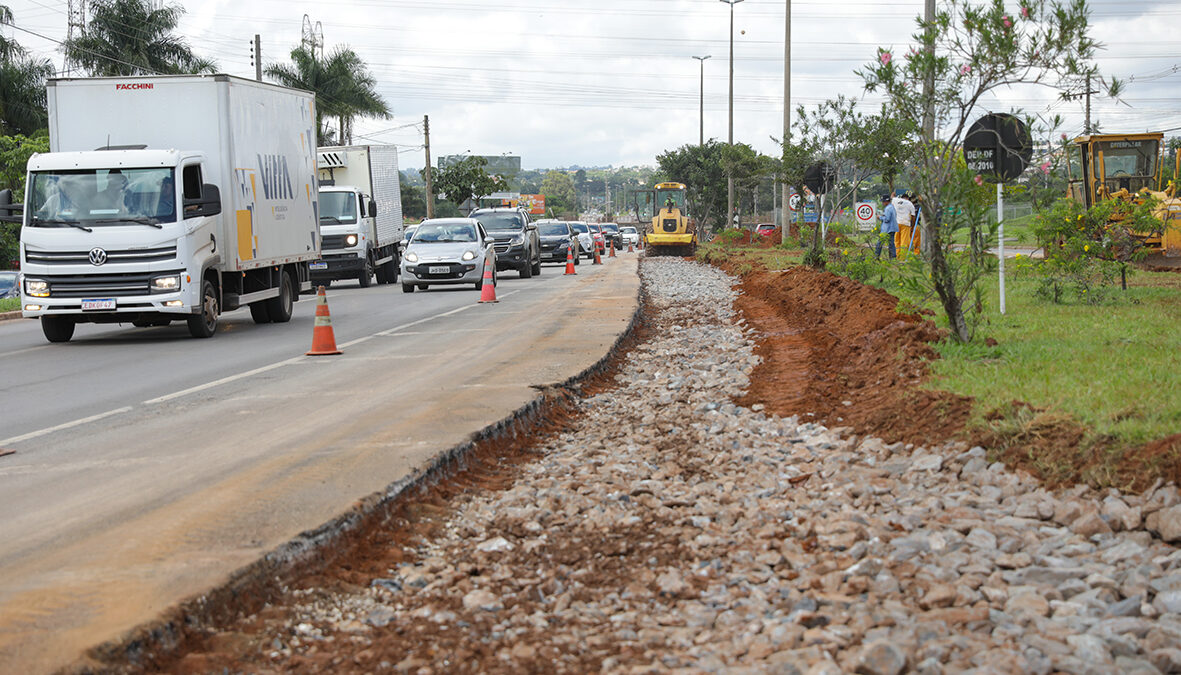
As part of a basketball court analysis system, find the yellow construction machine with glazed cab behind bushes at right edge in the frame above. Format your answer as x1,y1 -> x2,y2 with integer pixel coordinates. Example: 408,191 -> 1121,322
1066,132 -> 1181,258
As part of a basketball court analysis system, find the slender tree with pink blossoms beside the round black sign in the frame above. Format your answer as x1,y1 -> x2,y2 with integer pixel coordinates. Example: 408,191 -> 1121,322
859,0 -> 1118,342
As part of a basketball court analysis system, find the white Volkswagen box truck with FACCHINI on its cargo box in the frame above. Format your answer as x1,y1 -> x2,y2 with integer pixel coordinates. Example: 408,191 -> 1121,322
20,74 -> 320,342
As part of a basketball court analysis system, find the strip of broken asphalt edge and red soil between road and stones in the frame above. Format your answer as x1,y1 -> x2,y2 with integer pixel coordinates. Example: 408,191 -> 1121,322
76,257 -> 647,674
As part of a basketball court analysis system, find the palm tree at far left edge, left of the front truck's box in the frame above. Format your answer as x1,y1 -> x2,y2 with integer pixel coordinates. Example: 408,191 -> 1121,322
0,5 -> 54,136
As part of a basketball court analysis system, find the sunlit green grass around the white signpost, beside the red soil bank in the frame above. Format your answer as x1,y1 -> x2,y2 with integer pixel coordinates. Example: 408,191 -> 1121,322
928,269 -> 1181,444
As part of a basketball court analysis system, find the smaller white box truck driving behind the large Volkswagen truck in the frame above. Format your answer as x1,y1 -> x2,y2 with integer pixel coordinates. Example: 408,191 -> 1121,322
311,145 -> 403,288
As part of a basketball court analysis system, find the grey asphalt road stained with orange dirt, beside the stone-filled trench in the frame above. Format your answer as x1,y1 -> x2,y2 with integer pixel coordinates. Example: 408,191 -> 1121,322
0,255 -> 639,673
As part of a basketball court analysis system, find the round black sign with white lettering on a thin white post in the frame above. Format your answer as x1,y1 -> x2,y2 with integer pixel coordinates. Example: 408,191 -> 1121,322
964,112 -> 1033,314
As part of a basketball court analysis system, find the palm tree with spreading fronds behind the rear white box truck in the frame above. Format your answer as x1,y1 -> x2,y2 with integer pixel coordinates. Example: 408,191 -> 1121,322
266,45 -> 390,145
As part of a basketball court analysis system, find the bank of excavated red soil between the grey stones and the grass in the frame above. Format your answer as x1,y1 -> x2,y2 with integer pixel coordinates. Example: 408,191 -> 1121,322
716,256 -> 1181,491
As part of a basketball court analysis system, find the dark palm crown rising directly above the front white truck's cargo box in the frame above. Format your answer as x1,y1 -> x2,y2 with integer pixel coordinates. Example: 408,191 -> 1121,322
65,0 -> 216,77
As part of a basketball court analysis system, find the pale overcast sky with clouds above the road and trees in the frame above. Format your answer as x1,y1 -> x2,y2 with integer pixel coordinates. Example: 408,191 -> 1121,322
0,0 -> 1181,169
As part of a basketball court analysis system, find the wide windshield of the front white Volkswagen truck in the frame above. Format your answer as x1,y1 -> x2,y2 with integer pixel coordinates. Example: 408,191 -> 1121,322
28,168 -> 176,228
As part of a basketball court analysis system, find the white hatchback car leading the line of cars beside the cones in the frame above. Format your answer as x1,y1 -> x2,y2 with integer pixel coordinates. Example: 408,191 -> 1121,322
402,218 -> 496,293
